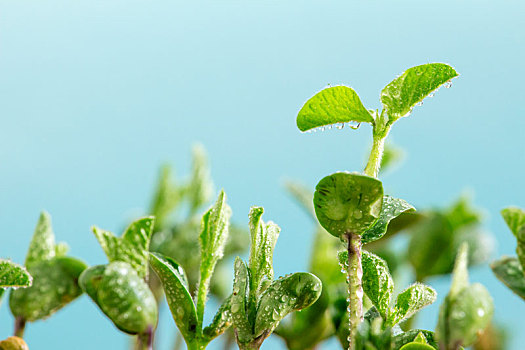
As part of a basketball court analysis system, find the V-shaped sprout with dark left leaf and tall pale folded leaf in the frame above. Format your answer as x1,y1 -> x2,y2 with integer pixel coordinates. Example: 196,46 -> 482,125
150,191 -> 231,350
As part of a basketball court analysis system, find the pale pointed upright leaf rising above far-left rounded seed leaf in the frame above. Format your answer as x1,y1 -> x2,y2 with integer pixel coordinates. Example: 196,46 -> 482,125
25,211 -> 56,269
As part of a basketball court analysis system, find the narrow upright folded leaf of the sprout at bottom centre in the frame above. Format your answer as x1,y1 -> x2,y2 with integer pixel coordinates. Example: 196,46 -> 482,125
249,207 -> 281,293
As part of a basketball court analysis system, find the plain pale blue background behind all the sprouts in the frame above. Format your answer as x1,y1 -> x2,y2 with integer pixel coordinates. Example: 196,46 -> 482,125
0,0 -> 525,350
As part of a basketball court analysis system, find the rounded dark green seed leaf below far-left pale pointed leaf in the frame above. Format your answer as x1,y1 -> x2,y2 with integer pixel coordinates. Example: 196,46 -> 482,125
9,257 -> 86,322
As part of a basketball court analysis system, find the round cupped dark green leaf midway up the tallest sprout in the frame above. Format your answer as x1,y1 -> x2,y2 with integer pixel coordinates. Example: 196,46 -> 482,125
314,172 -> 383,238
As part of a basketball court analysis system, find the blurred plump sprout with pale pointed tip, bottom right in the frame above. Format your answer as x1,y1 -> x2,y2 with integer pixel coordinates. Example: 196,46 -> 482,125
436,243 -> 494,350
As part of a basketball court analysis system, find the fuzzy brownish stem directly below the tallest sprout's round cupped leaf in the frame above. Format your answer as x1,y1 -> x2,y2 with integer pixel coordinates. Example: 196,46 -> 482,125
346,234 -> 363,350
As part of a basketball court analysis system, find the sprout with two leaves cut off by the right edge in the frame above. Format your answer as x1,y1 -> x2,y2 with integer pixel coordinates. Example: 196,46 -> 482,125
490,207 -> 525,300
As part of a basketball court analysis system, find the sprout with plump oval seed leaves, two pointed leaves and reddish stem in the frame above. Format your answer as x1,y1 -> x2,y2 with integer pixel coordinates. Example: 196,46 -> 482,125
79,217 -> 158,349
